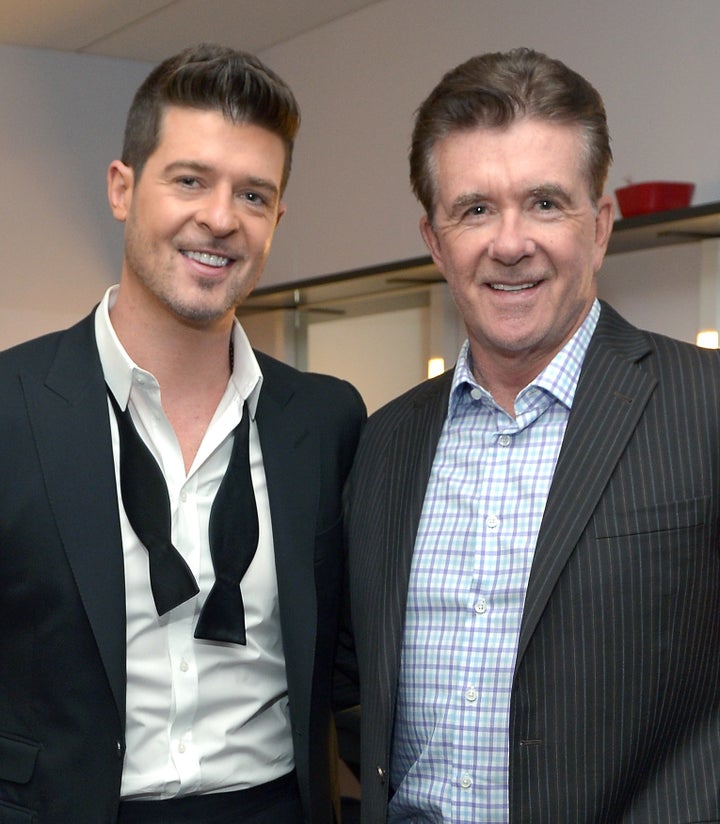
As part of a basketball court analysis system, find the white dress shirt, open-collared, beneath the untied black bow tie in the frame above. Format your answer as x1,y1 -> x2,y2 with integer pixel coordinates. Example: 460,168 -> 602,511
95,287 -> 294,799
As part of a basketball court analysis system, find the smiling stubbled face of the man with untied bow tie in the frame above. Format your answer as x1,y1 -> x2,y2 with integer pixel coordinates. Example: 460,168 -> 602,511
109,106 -> 285,325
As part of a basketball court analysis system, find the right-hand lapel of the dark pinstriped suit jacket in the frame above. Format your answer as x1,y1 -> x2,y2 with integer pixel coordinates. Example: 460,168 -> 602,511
516,304 -> 657,667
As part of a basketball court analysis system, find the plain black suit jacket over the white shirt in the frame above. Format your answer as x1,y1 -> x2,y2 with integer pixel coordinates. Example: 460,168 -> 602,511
0,315 -> 364,824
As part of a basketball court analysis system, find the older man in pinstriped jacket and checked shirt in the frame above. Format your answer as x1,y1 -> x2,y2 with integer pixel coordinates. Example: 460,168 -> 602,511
346,49 -> 720,824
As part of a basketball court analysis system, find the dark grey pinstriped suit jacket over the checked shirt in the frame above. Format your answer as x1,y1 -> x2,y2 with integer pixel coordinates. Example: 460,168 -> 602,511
346,304 -> 720,824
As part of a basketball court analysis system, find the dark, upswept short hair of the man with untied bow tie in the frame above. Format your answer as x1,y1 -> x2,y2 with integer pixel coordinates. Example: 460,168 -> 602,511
122,43 -> 300,193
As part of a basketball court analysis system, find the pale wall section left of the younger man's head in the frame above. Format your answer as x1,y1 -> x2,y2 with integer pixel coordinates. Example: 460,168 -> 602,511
0,46 -> 149,348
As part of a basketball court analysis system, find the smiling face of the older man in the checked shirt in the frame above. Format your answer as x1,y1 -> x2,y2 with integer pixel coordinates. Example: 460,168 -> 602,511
421,118 -> 613,375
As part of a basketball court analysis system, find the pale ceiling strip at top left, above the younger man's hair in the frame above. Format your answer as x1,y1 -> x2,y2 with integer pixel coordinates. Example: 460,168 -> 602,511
0,0 -> 378,62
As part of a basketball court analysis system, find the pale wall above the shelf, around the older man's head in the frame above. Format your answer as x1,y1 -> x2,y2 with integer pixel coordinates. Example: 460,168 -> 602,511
263,0 -> 720,285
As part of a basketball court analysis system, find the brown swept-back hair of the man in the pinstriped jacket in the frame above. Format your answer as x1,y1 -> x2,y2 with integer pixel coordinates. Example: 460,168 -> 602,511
410,48 -> 612,220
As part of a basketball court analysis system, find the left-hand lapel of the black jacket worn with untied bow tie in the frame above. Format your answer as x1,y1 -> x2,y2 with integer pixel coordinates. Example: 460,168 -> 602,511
21,315 -> 125,720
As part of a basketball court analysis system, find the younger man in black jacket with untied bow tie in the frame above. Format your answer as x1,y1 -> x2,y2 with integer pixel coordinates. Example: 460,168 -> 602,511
0,46 -> 365,824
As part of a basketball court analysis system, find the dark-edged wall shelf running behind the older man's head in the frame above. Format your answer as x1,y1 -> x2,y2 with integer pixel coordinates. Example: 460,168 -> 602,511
238,201 -> 720,316
